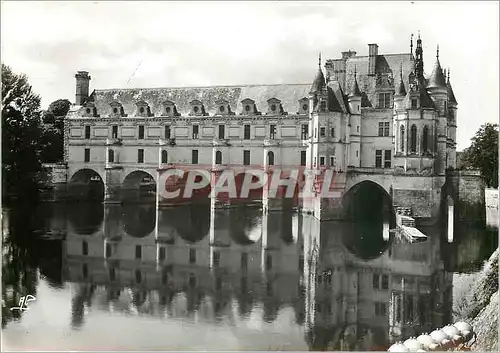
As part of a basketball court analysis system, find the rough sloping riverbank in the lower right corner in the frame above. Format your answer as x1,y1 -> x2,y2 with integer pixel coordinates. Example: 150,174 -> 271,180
457,248 -> 499,351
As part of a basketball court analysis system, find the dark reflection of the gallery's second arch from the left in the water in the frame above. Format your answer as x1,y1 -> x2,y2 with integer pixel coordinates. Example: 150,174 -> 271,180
122,204 -> 156,238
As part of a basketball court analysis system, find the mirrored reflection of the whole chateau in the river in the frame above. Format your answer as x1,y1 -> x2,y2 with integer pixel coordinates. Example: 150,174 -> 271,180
48,204 -> 451,350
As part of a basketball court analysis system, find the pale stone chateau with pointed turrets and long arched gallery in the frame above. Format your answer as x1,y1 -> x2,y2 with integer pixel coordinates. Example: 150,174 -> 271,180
54,36 -> 484,223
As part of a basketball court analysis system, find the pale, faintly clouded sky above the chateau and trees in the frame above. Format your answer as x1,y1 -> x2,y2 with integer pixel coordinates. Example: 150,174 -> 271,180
1,1 -> 499,150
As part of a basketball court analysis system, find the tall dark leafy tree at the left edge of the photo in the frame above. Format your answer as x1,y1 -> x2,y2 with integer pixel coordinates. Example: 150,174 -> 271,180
2,63 -> 42,201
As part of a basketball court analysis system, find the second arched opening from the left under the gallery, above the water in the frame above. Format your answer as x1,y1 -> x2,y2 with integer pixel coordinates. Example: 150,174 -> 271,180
122,170 -> 156,202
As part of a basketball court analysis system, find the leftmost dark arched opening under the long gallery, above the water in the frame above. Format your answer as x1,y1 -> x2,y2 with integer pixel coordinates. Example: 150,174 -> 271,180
69,169 -> 104,201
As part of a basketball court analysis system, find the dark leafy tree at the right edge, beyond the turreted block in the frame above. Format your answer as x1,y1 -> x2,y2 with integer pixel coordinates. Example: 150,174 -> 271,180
462,123 -> 498,188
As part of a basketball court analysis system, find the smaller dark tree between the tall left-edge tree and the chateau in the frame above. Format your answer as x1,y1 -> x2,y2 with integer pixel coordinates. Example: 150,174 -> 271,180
41,99 -> 71,163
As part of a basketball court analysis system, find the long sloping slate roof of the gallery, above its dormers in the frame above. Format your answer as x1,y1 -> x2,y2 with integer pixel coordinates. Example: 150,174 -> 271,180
79,83 -> 311,116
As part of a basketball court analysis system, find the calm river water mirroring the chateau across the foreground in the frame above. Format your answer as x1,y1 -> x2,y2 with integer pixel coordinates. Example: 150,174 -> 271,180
2,203 -> 498,351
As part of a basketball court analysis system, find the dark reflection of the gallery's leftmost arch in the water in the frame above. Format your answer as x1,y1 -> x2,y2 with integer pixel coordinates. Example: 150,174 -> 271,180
67,203 -> 104,235
